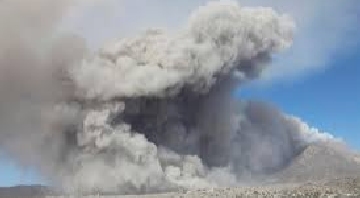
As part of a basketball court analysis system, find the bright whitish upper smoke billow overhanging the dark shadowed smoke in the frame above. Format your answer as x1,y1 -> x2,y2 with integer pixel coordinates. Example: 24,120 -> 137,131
72,2 -> 294,99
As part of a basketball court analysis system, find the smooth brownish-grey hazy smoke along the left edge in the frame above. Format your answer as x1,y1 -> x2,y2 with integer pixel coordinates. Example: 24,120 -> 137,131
0,0 -> 86,167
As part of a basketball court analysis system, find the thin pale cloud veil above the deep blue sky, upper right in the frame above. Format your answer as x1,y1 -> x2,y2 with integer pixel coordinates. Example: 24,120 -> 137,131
241,0 -> 360,80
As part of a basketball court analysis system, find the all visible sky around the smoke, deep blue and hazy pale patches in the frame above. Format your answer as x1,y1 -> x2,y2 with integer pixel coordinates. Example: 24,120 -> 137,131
0,0 -> 360,186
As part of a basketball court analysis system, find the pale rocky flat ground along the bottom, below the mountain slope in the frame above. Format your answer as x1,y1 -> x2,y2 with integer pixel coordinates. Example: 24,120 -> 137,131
40,178 -> 360,198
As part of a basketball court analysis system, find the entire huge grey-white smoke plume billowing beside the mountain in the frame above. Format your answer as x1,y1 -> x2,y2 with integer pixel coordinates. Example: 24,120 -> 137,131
0,0 -> 338,193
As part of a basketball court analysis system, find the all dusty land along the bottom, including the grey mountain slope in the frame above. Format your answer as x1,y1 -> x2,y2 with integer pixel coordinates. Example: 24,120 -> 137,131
0,143 -> 360,198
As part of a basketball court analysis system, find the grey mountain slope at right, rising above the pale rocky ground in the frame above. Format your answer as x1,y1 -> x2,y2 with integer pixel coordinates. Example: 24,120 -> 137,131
275,142 -> 360,183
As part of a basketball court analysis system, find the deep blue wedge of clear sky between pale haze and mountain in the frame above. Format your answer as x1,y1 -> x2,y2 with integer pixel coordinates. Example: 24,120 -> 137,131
236,47 -> 360,150
